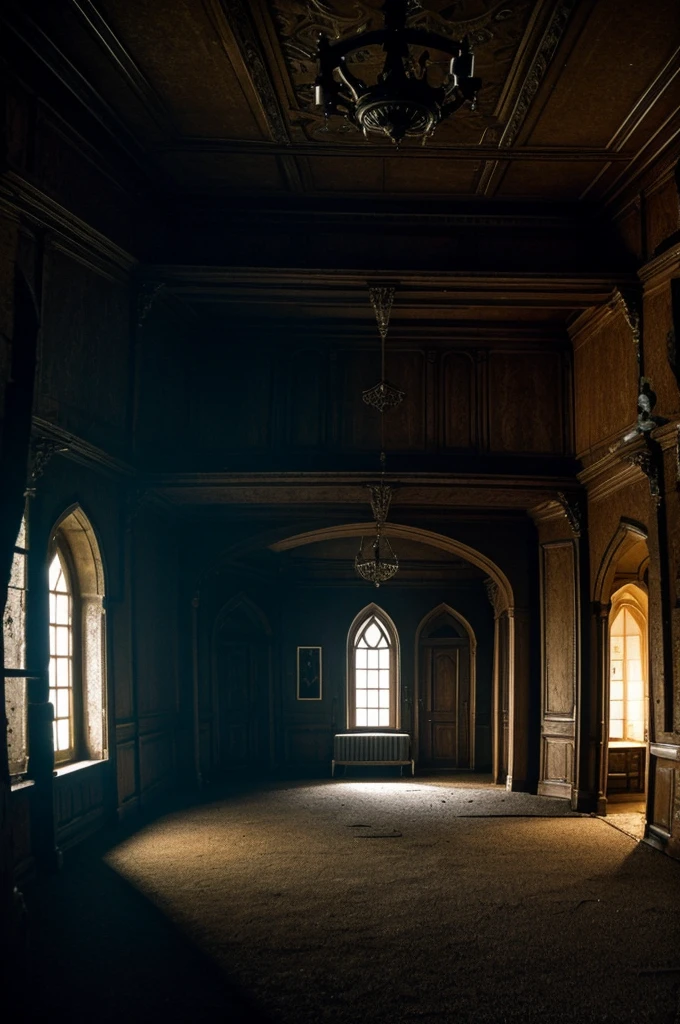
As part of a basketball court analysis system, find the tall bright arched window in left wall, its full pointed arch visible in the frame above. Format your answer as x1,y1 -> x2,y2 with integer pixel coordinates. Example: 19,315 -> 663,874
48,508 -> 108,764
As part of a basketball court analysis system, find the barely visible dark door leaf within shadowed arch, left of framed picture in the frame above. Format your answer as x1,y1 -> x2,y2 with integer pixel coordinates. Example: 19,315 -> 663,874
217,641 -> 268,769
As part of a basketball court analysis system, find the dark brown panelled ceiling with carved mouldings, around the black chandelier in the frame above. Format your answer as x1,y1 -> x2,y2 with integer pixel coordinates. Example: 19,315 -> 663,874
10,0 -> 680,201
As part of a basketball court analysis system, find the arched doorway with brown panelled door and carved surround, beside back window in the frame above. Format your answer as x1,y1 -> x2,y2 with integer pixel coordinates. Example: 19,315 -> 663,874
416,605 -> 476,769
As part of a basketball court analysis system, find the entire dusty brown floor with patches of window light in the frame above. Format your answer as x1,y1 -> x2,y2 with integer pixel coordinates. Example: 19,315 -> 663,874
23,776 -> 680,1024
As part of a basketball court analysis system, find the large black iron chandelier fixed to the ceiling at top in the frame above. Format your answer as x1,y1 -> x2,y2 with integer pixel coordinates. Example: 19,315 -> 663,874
314,0 -> 481,145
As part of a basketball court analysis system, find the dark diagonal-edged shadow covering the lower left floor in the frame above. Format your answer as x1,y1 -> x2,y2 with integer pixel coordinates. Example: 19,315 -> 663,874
22,833 -> 271,1024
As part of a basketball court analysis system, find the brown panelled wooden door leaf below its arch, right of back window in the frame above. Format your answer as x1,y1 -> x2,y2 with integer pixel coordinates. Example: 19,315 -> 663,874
420,640 -> 470,768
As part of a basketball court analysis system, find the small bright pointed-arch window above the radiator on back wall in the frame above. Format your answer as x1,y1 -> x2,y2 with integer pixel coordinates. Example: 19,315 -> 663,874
347,606 -> 399,729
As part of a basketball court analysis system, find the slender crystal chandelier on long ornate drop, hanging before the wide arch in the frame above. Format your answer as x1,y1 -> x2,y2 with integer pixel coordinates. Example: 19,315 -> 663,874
354,288 -> 405,587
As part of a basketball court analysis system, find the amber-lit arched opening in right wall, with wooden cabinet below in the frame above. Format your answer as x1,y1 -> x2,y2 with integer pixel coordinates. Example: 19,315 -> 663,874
605,584 -> 649,810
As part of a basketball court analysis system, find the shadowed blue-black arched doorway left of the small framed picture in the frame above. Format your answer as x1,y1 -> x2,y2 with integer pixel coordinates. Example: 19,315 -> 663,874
211,597 -> 271,774
